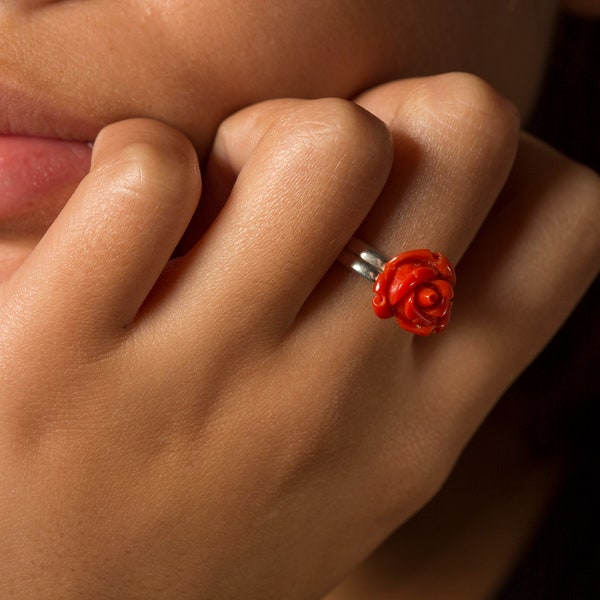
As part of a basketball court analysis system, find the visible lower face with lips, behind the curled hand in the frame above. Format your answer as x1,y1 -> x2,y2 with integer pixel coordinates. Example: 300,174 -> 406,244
0,0 -> 556,276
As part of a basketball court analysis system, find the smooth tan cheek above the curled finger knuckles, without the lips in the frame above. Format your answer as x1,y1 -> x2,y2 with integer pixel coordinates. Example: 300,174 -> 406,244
12,0 -> 552,162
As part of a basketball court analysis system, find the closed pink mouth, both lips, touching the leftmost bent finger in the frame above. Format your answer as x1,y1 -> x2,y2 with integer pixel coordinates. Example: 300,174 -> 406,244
0,82 -> 101,226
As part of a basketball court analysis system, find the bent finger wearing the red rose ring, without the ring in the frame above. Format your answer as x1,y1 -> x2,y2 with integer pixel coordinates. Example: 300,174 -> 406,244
300,74 -> 519,357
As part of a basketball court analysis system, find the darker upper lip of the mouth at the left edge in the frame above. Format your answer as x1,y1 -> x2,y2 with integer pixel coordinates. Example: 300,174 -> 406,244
0,80 -> 102,142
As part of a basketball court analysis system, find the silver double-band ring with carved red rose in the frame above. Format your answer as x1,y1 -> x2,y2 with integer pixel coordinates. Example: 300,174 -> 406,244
338,238 -> 456,336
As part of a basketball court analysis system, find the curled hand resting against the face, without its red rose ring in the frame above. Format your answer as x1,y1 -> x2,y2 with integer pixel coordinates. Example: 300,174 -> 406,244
0,75 -> 600,600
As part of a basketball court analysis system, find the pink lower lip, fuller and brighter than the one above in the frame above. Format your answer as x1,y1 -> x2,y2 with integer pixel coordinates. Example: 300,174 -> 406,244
0,136 -> 92,222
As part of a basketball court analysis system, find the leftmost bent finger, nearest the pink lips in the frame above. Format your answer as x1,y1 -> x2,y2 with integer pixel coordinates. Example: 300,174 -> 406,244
2,119 -> 200,338
